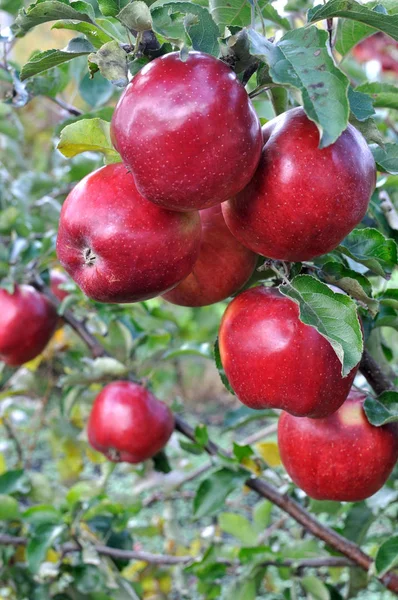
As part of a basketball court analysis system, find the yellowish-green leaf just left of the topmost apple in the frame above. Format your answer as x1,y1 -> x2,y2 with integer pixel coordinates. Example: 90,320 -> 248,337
58,118 -> 120,163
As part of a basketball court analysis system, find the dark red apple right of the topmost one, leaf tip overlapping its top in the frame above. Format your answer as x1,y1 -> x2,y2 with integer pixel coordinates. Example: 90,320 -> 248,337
223,108 -> 376,262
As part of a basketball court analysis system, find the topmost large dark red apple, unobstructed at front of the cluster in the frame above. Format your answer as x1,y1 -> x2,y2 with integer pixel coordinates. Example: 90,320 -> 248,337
111,52 -> 262,211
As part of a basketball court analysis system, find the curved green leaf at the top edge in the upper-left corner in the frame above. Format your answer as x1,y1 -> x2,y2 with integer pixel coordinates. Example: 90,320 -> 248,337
11,0 -> 93,37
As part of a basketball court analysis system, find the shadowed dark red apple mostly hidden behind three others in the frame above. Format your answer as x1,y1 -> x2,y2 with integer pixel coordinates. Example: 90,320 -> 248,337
163,205 -> 257,306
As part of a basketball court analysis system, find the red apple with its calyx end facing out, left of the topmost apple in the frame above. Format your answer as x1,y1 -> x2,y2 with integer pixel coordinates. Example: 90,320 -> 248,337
57,163 -> 201,302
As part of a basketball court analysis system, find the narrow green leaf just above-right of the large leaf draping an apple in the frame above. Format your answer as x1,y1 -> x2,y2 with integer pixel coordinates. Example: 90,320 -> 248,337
322,262 -> 379,317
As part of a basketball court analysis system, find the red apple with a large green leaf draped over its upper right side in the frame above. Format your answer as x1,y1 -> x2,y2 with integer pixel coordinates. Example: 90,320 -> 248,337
219,287 -> 358,418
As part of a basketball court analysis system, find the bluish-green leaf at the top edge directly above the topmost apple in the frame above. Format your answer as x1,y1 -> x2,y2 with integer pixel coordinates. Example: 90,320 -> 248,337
151,0 -> 220,56
